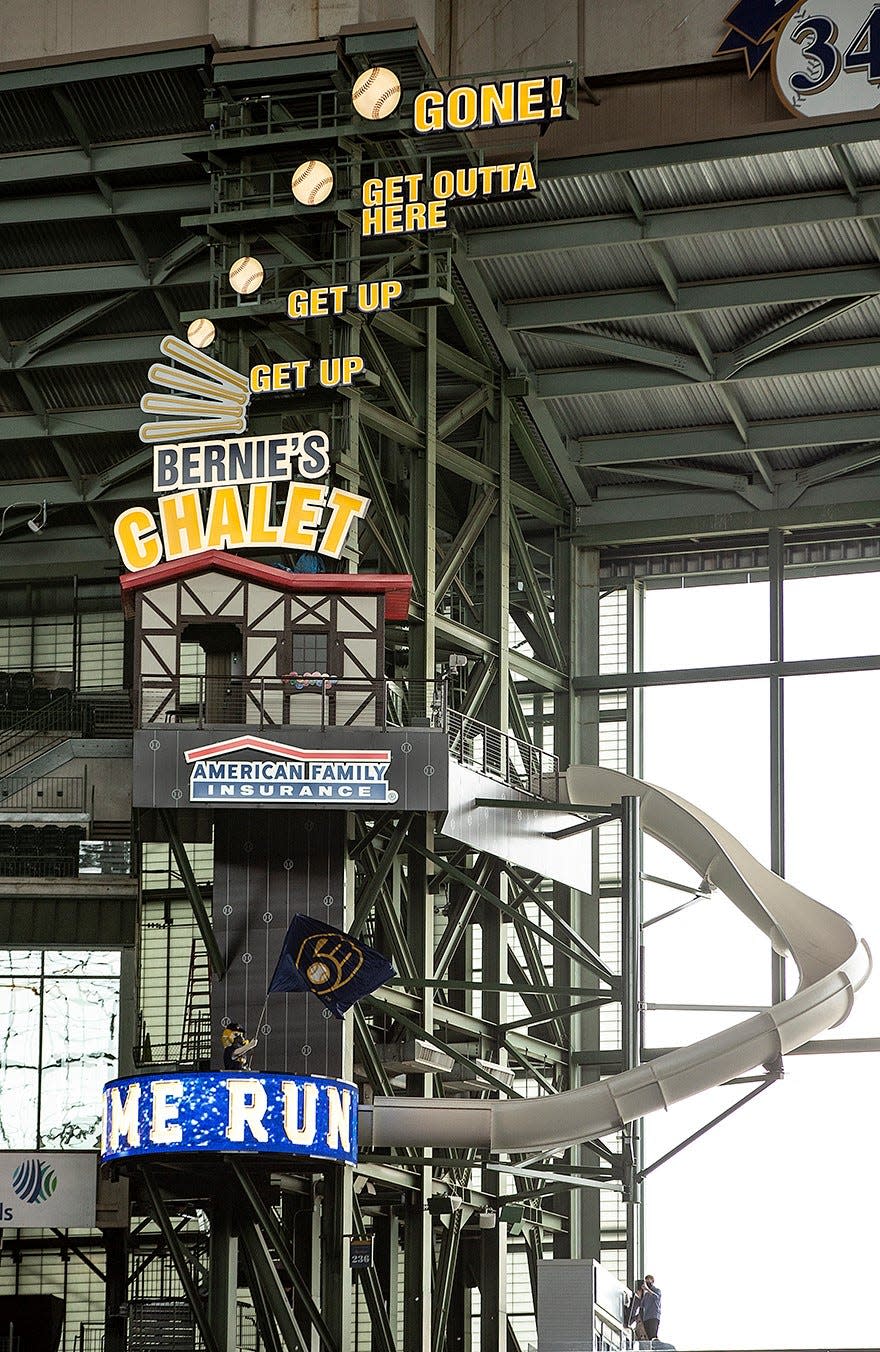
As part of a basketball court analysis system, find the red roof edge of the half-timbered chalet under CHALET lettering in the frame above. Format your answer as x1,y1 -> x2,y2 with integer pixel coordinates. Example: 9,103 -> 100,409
119,549 -> 412,619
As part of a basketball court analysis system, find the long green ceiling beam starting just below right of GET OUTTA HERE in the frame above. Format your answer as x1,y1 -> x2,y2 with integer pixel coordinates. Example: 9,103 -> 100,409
465,185 -> 880,260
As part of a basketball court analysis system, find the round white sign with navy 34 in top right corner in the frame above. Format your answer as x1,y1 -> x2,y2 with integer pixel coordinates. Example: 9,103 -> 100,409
773,0 -> 880,118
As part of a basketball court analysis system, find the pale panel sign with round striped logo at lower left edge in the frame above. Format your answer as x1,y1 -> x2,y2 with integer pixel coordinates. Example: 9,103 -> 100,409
0,1151 -> 97,1229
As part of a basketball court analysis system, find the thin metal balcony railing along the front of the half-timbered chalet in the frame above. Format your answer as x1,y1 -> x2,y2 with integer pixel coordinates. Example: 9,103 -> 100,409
137,672 -> 446,730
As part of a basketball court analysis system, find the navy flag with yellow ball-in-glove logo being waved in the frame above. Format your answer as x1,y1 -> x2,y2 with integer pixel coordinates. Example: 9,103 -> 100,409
266,915 -> 395,1018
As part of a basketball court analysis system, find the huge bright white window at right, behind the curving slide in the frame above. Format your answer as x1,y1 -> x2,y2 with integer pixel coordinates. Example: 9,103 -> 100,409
635,573 -> 880,1348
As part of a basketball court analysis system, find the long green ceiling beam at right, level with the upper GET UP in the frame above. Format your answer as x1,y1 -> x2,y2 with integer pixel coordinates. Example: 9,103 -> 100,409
499,265 -> 880,328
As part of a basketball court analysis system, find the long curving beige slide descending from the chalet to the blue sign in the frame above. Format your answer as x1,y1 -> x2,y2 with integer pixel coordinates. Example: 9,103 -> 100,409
358,765 -> 871,1152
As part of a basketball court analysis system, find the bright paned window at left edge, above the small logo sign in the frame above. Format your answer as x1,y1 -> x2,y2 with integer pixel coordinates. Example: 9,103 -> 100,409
0,949 -> 120,1151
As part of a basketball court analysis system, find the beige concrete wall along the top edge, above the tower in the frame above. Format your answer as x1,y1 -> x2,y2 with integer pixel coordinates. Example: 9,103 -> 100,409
0,0 -> 729,77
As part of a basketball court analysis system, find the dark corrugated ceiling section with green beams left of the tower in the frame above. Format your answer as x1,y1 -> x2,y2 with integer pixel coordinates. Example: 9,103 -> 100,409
0,42 -> 211,580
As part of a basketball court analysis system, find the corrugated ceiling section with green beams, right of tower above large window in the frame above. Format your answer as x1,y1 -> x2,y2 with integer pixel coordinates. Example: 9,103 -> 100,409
465,110 -> 880,545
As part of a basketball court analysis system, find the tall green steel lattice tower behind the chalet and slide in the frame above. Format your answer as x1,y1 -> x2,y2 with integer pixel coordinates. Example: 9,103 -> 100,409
161,35 -> 625,1352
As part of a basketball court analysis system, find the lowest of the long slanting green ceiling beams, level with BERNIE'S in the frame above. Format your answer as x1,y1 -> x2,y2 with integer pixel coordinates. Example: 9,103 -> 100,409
572,412 -> 877,466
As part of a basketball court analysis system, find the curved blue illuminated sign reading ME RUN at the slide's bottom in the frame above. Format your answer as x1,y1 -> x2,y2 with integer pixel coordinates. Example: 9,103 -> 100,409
101,1071 -> 357,1164
